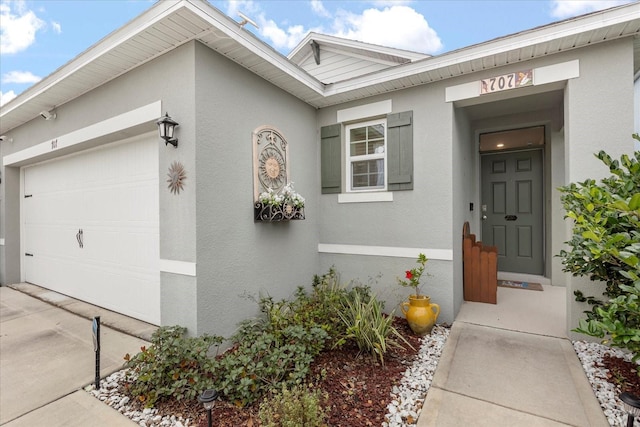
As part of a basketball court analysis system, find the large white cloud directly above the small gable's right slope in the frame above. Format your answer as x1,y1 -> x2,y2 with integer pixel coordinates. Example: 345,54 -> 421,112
334,5 -> 442,54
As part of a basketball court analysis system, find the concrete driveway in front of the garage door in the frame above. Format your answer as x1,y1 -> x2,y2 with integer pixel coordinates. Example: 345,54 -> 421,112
0,284 -> 155,427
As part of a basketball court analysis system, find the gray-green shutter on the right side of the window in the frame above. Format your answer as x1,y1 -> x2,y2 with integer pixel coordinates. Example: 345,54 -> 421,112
387,111 -> 413,191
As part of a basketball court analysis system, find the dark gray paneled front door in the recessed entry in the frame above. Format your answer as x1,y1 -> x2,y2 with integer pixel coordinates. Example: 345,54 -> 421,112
481,150 -> 544,275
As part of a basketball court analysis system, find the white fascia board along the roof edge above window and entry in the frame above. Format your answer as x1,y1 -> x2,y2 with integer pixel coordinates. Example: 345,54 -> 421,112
325,2 -> 640,97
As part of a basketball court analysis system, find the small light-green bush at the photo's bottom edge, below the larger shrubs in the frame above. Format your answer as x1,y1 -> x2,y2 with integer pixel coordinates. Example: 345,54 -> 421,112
258,386 -> 327,427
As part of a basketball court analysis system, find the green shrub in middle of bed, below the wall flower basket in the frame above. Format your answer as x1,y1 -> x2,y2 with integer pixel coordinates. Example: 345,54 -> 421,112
214,322 -> 327,406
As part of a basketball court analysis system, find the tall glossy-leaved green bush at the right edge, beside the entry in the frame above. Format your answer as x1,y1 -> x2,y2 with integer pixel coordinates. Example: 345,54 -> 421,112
560,140 -> 640,360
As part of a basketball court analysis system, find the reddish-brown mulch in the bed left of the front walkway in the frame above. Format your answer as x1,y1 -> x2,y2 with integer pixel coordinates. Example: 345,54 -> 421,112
146,318 -> 420,427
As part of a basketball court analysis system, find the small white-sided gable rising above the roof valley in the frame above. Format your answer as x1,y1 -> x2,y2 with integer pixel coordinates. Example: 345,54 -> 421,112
287,32 -> 430,84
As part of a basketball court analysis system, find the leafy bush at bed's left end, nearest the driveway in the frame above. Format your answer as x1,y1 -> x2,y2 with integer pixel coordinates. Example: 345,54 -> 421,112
124,326 -> 223,407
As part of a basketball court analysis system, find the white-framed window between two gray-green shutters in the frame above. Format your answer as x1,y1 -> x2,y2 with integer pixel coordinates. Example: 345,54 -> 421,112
345,119 -> 387,191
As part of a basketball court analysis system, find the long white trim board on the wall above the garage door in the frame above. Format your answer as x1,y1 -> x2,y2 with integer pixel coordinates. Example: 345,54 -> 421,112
2,101 -> 162,166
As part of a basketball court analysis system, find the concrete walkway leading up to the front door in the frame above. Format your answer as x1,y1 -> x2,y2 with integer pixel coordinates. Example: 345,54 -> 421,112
417,286 -> 609,427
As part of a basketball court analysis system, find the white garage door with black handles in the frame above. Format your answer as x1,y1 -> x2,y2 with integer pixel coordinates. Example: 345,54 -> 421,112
23,135 -> 160,324
